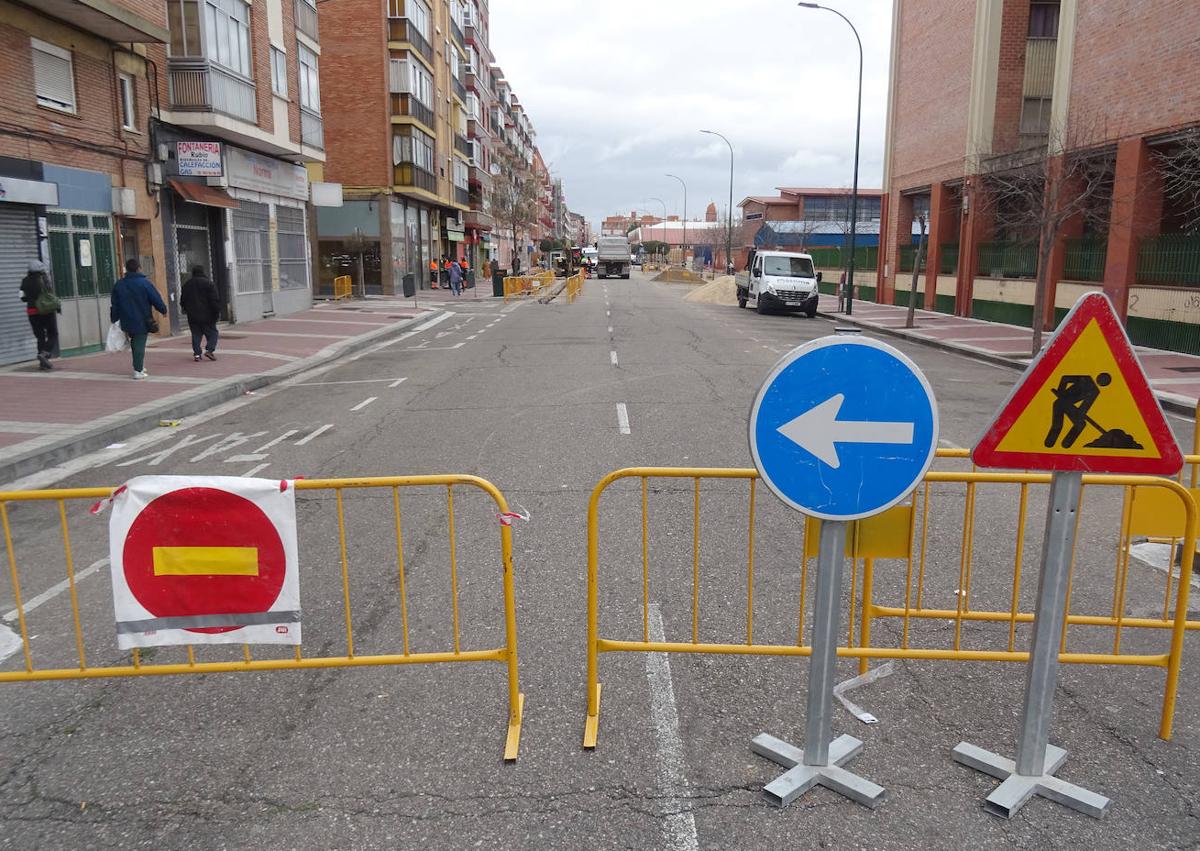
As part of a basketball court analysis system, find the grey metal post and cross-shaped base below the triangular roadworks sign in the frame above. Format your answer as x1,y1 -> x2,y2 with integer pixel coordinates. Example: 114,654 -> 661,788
954,473 -> 1110,819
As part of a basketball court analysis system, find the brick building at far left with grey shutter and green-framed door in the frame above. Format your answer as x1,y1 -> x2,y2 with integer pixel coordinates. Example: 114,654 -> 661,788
0,0 -> 169,364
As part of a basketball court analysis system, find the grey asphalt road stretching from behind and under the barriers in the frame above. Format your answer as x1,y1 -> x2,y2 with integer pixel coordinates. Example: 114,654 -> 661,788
0,272 -> 1200,849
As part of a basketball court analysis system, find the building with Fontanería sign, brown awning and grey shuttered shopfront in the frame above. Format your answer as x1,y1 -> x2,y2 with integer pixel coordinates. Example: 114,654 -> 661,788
158,0 -> 325,329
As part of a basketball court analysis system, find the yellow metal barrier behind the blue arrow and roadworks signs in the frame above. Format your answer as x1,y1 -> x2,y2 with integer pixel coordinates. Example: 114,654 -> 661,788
583,467 -> 1198,748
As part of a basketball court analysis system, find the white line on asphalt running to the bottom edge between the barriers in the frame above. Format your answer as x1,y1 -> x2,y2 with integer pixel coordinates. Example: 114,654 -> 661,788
646,603 -> 700,851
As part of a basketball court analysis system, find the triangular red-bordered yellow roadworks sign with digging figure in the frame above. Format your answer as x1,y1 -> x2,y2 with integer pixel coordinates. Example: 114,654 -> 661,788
971,293 -> 1183,475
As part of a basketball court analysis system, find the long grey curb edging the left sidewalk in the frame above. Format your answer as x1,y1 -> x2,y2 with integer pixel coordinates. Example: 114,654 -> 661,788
0,310 -> 445,484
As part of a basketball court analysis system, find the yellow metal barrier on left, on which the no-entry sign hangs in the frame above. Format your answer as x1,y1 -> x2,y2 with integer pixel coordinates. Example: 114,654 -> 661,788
0,475 -> 524,760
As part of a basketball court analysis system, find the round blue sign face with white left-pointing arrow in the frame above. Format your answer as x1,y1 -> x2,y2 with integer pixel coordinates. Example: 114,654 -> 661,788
750,336 -> 937,520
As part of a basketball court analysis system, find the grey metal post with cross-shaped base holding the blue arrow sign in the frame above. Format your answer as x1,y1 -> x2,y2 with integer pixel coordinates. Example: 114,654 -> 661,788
750,521 -> 886,809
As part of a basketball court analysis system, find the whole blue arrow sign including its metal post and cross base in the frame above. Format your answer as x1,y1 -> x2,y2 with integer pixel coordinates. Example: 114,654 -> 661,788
750,336 -> 937,808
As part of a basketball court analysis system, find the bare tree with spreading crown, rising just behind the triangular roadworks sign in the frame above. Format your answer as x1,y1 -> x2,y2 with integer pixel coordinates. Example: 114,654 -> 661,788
976,117 -> 1116,354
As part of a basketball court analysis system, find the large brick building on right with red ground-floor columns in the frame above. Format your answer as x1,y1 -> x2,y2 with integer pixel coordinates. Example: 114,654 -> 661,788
877,0 -> 1200,350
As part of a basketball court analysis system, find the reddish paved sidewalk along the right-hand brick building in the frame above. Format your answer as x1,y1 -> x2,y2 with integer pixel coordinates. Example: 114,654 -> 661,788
818,295 -> 1200,416
